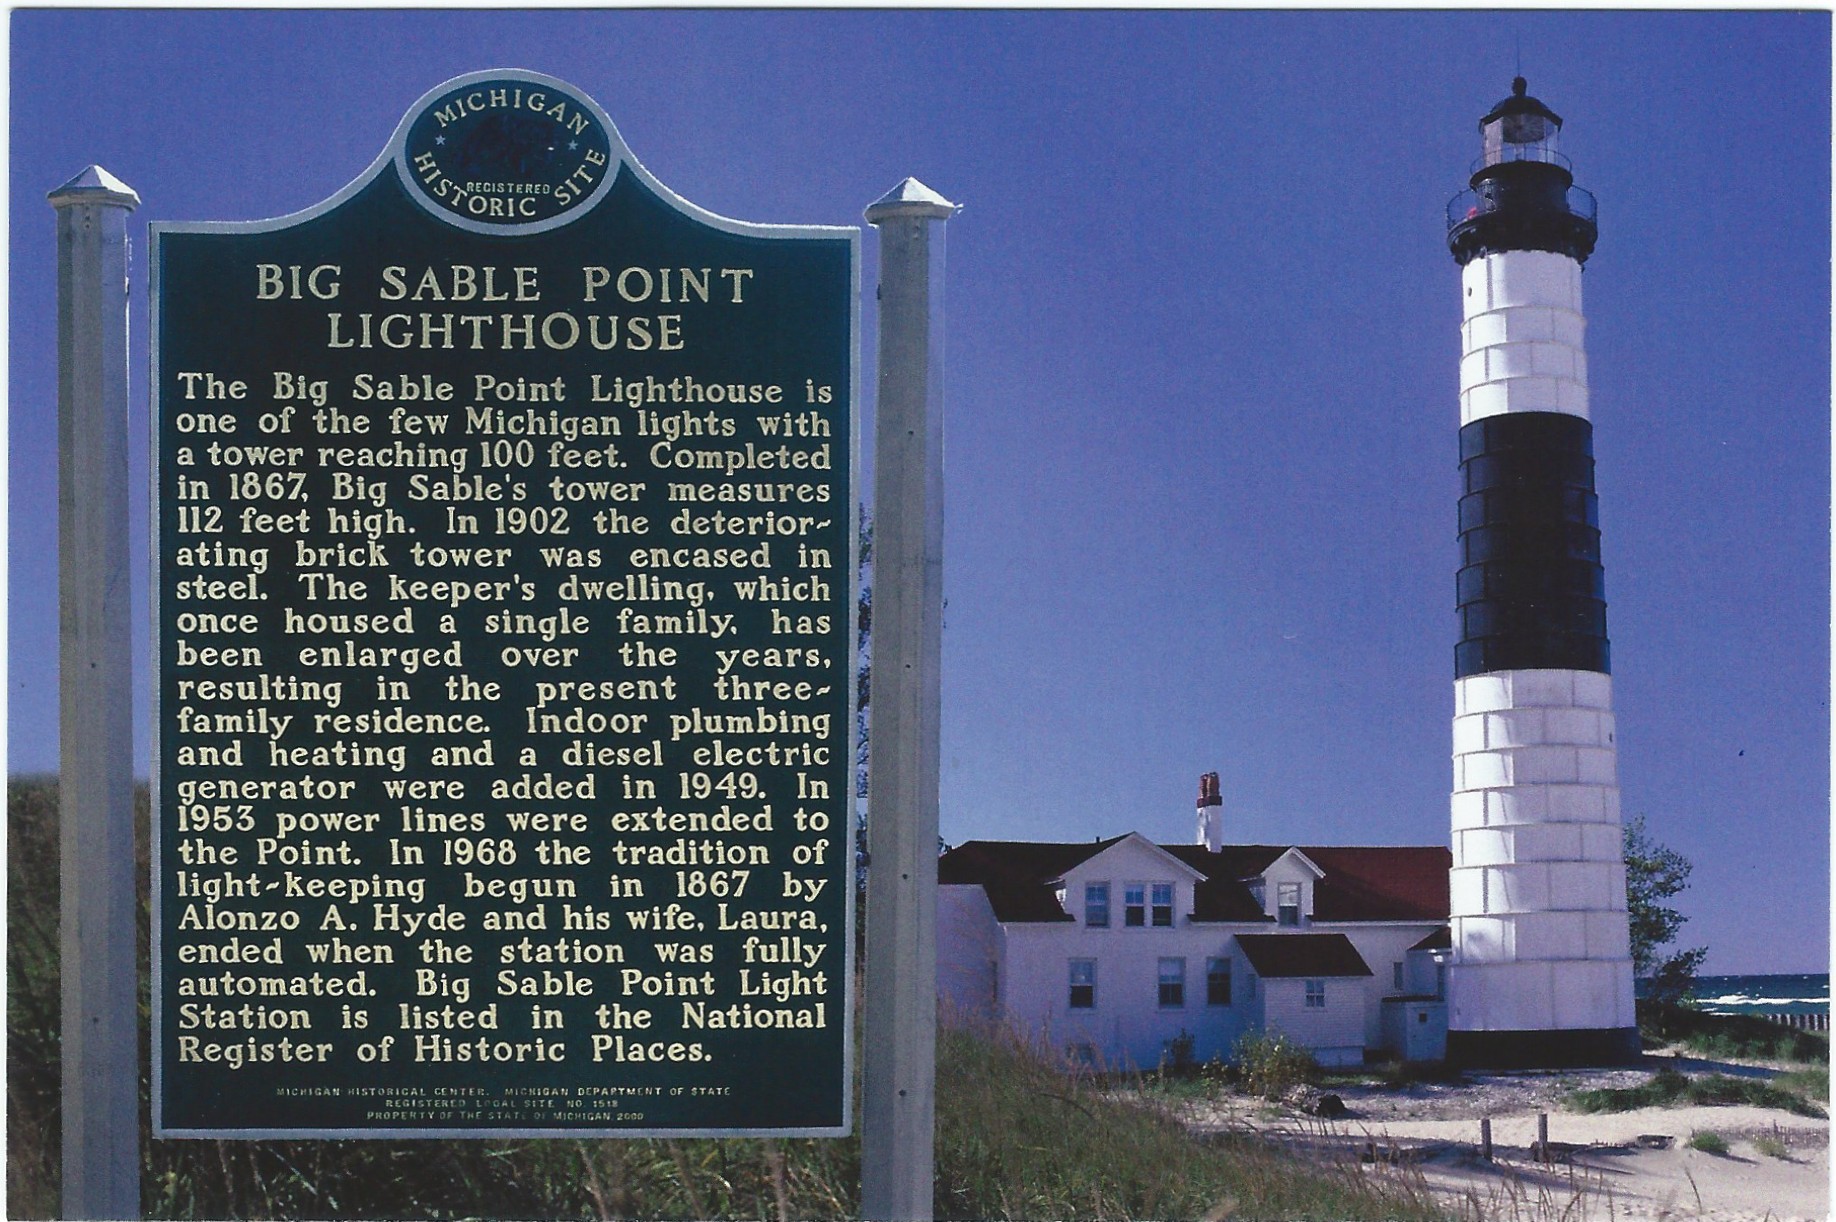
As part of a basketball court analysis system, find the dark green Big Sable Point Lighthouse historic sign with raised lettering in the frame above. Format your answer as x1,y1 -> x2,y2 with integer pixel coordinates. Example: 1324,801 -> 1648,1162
152,72 -> 859,1138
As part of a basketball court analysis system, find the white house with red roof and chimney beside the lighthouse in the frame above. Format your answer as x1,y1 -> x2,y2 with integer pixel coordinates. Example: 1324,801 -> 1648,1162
936,772 -> 1452,1068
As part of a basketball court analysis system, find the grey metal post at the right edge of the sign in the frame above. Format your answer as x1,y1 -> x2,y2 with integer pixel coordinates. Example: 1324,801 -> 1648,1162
861,178 -> 957,1222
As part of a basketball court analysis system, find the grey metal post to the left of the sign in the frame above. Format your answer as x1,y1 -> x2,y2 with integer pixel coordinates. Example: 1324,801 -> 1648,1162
50,165 -> 140,1218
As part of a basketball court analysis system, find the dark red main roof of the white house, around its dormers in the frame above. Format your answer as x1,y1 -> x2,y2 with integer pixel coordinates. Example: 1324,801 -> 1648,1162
936,837 -> 1452,924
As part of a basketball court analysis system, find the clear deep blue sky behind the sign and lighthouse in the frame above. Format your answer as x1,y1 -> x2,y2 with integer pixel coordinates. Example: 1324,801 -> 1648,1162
7,9 -> 1830,972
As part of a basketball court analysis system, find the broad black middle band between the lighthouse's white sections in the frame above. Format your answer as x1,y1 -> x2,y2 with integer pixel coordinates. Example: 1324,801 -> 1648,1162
1454,411 -> 1610,679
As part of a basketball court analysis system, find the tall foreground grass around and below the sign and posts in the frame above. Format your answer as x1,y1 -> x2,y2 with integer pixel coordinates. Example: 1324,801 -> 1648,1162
7,778 -> 1439,1222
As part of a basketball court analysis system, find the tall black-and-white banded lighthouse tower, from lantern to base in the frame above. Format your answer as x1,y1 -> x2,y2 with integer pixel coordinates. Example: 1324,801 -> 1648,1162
1447,77 -> 1638,1066
